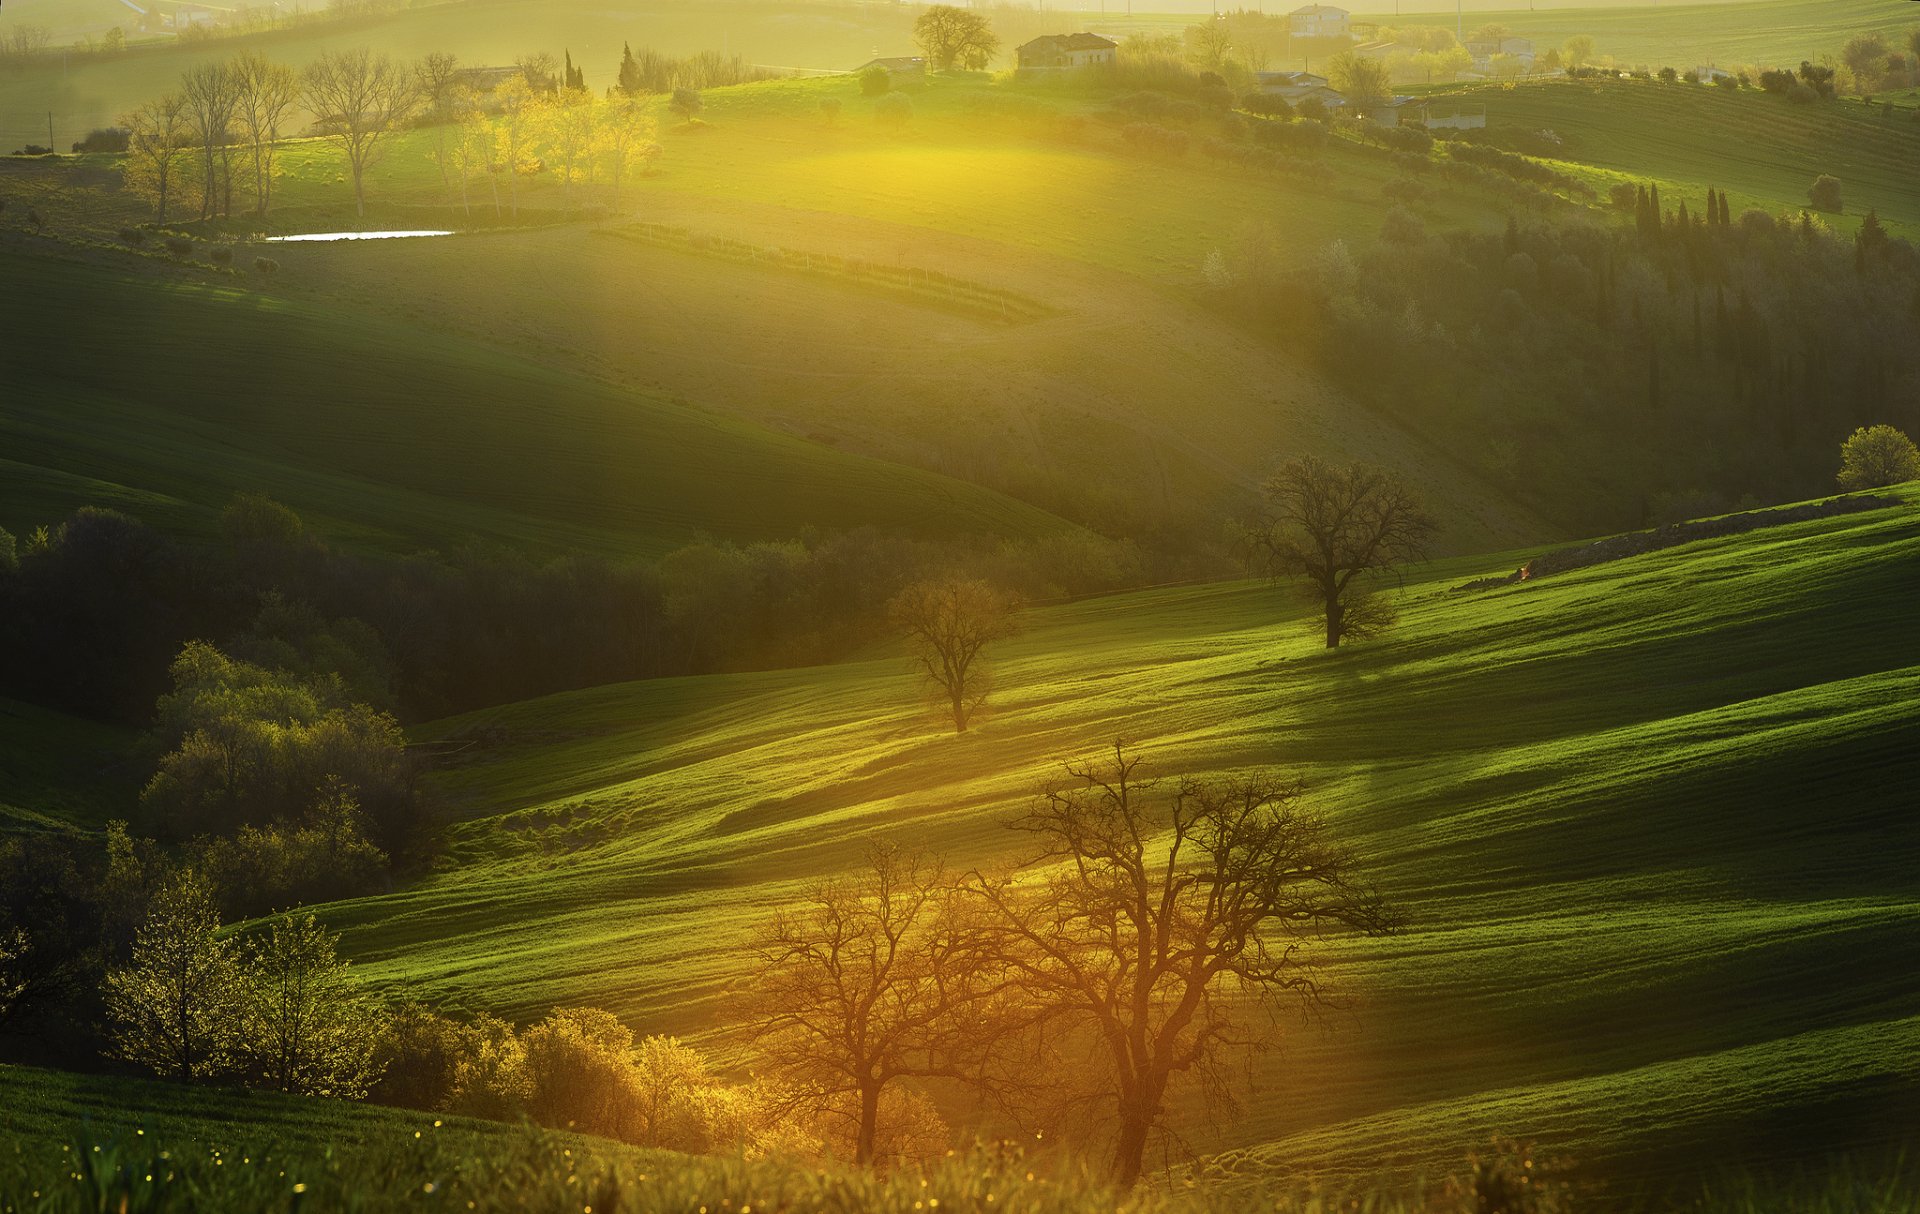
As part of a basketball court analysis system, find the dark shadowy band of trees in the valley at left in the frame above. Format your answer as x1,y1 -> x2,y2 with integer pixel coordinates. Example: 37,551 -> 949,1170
0,496 -> 1187,726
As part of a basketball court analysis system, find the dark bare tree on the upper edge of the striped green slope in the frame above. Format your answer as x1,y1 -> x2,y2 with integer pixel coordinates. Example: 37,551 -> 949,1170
1242,455 -> 1438,649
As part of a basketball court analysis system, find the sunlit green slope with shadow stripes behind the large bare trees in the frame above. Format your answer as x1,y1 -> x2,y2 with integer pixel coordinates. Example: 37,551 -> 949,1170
255,490 -> 1920,1172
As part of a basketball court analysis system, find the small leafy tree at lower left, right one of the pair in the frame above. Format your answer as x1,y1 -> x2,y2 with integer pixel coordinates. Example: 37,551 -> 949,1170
240,914 -> 380,1101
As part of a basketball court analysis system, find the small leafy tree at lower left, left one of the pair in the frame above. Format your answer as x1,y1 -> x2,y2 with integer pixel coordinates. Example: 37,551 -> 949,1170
102,870 -> 246,1081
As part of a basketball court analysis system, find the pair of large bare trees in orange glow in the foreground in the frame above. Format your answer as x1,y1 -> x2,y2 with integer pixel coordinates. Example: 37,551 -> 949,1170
753,745 -> 1398,1185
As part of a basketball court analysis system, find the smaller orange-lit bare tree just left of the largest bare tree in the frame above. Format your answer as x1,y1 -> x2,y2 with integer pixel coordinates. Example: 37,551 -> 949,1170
755,843 -> 966,1164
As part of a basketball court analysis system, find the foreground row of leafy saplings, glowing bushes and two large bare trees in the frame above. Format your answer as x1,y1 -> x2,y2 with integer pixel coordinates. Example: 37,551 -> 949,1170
0,745 -> 1400,1185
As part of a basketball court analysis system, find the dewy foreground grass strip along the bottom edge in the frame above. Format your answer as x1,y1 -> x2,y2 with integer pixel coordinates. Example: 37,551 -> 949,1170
0,1066 -> 1920,1214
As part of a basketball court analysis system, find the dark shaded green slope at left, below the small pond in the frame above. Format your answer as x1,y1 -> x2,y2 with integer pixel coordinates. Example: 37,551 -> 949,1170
0,257 -> 1066,553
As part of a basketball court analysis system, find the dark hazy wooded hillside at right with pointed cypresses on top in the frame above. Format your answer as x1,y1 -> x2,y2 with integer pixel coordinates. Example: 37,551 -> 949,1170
1217,190 -> 1920,532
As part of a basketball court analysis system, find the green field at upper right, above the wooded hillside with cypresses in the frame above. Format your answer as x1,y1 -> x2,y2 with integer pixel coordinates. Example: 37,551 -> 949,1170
1440,81 -> 1920,238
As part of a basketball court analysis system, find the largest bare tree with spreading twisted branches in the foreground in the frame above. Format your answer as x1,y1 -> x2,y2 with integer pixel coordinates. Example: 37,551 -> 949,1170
968,743 -> 1398,1185
